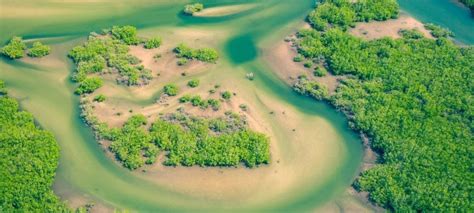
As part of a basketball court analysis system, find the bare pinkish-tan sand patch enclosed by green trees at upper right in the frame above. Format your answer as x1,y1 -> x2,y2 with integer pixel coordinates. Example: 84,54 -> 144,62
349,14 -> 433,40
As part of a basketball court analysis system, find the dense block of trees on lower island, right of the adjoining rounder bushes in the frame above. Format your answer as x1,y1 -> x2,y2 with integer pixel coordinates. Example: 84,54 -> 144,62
150,113 -> 270,167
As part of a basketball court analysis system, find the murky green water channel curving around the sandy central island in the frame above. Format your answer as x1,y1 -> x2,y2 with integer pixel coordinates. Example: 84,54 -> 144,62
0,0 -> 472,212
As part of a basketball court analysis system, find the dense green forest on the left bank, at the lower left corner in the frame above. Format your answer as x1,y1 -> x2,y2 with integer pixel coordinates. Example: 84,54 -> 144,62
0,81 -> 67,212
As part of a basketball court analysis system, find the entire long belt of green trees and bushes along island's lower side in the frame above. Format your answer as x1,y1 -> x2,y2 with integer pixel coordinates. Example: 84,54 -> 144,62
99,113 -> 270,170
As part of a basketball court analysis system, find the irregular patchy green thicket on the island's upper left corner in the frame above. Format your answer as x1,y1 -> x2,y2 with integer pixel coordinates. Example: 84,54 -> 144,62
69,26 -> 152,89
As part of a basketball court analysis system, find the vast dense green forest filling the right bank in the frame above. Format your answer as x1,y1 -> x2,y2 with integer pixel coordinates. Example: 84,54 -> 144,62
296,1 -> 474,212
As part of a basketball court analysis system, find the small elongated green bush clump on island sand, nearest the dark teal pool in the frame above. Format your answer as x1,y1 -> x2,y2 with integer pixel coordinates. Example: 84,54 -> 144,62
174,43 -> 219,63
